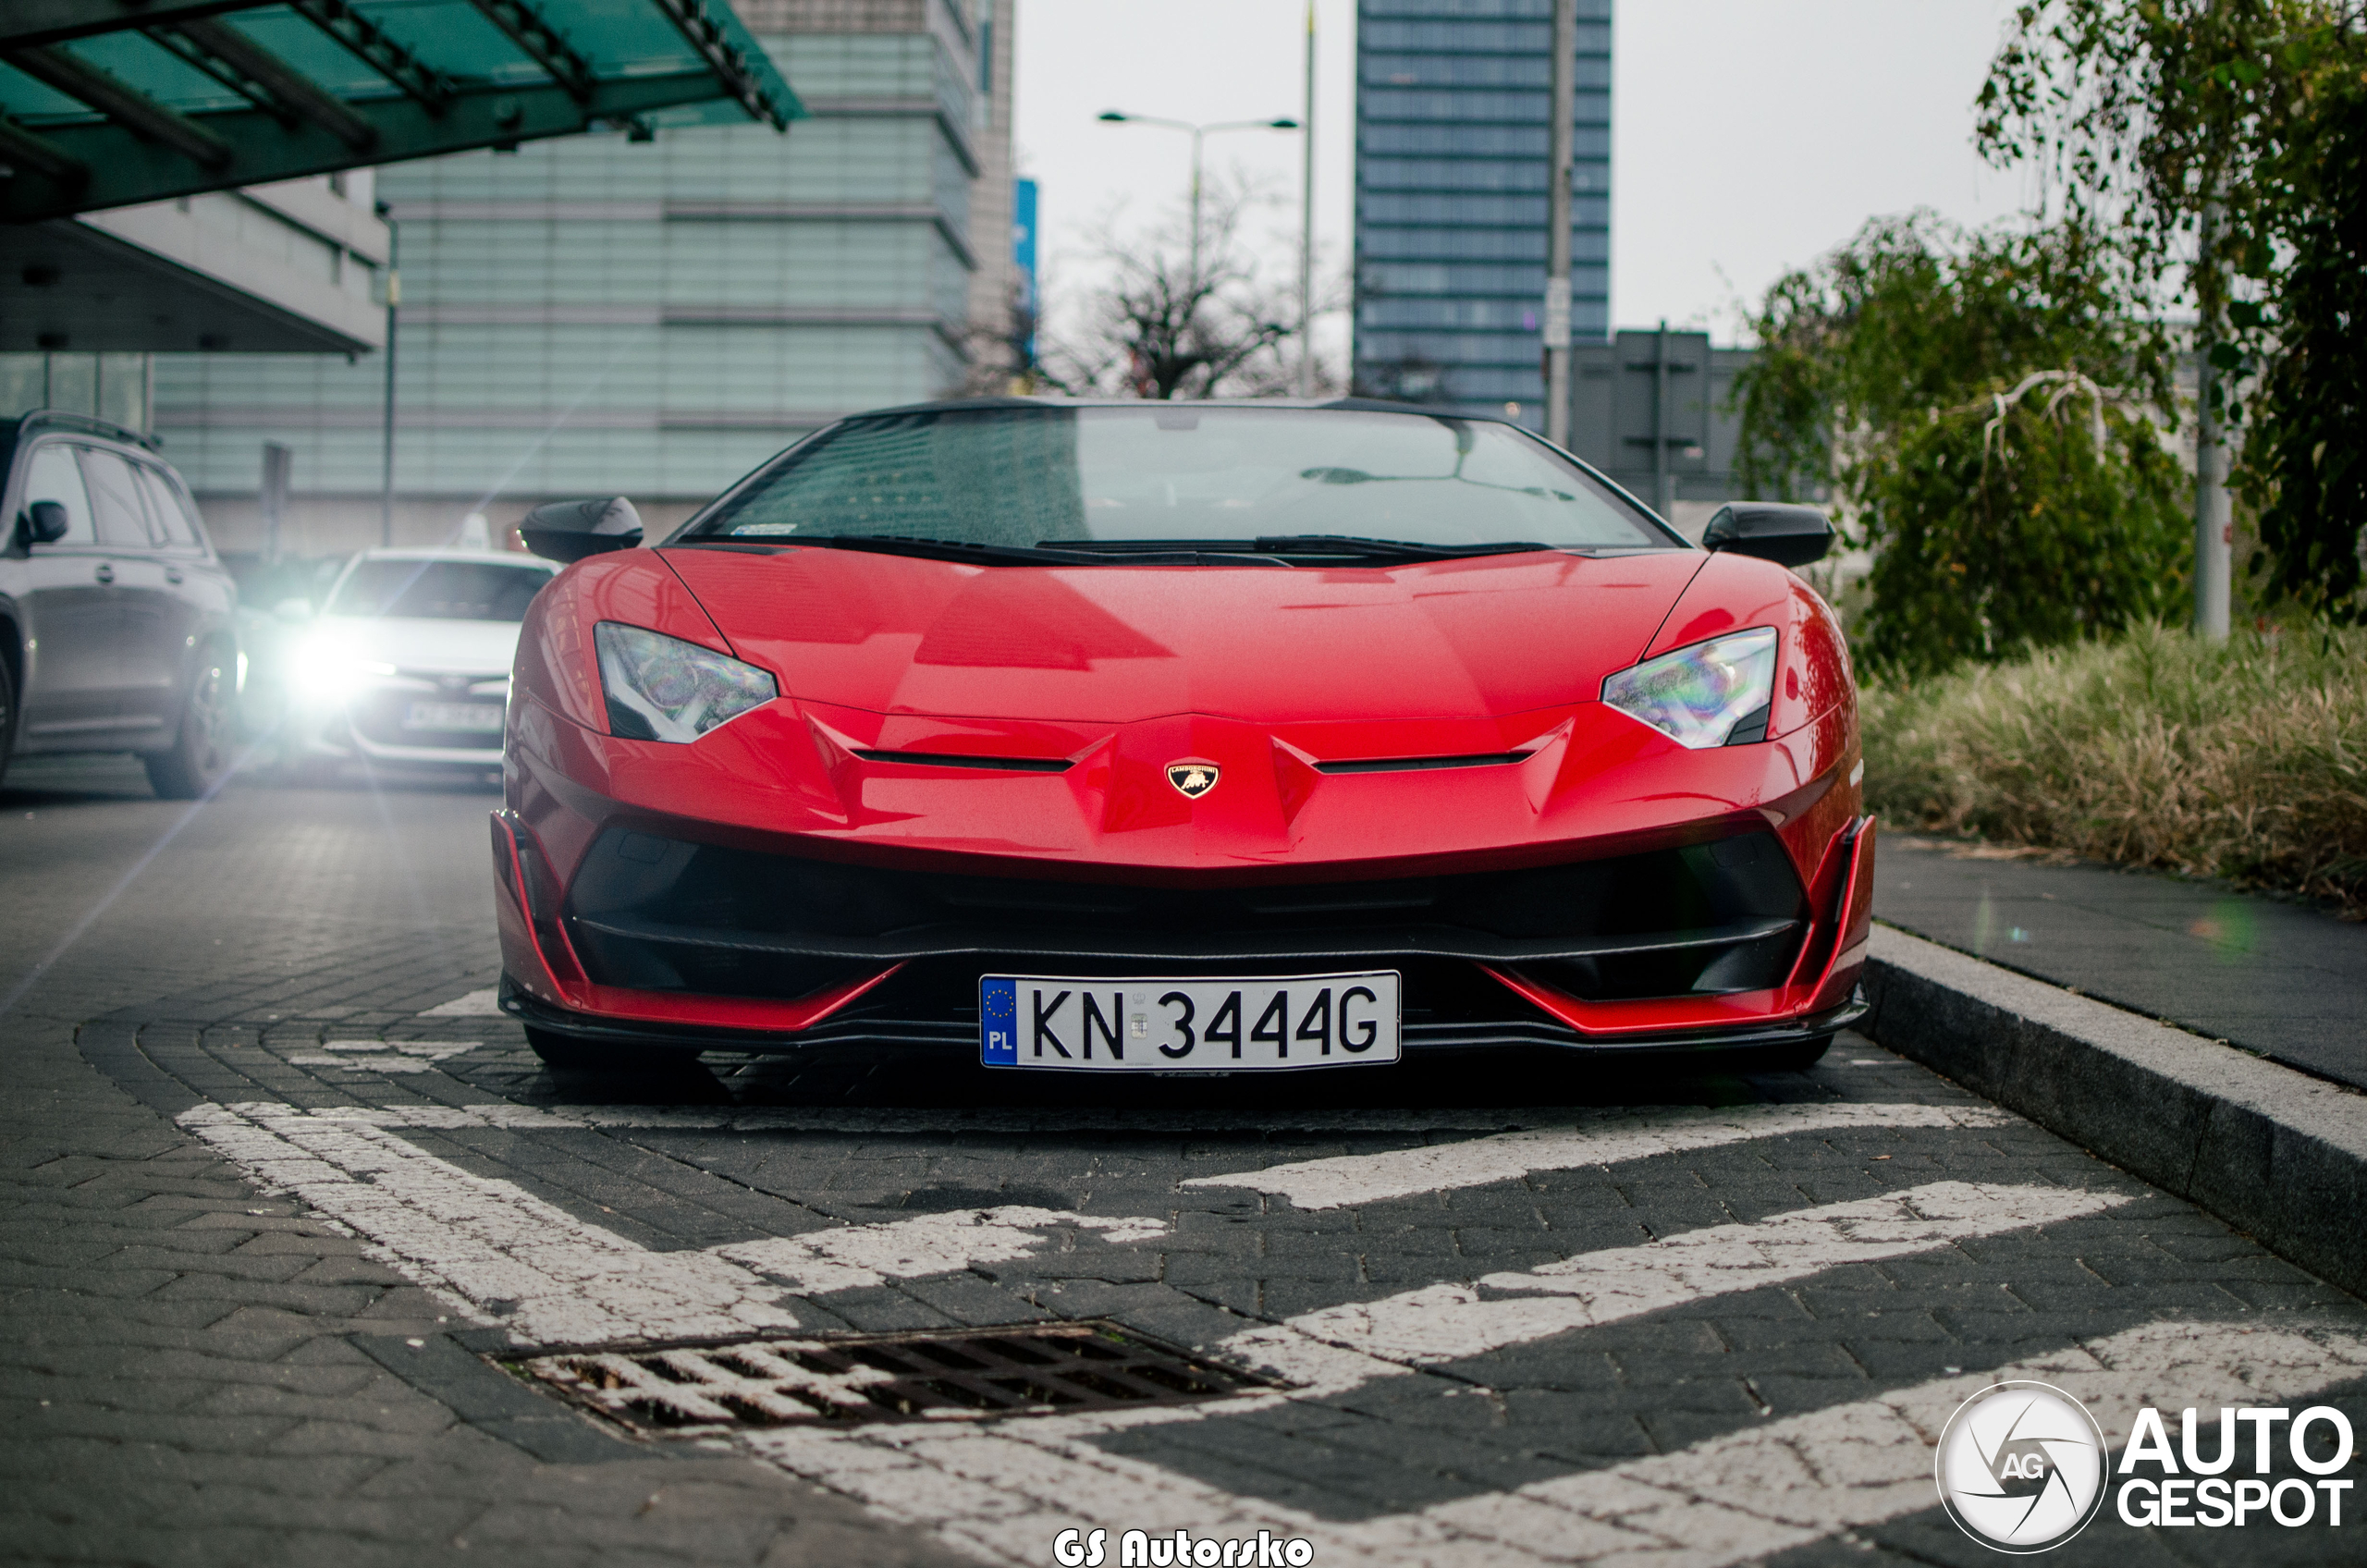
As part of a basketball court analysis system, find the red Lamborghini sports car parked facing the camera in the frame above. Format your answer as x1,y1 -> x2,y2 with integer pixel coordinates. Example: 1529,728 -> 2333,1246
492,398 -> 1875,1073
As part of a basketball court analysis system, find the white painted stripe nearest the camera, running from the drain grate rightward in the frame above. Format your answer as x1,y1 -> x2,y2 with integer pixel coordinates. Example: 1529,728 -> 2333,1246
748,1322 -> 2367,1568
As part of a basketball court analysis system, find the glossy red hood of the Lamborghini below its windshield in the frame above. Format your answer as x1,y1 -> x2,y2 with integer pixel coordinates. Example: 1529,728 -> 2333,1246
660,547 -> 1709,725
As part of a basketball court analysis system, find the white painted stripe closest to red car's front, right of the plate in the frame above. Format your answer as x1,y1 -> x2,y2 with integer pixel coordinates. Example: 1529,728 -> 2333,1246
1184,1101 -> 2012,1208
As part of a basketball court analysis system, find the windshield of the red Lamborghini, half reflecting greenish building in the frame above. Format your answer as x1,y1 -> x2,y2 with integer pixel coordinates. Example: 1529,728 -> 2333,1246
684,403 -> 1681,549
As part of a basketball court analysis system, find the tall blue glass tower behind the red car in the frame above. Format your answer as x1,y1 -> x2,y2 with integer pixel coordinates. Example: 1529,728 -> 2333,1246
1354,0 -> 1612,426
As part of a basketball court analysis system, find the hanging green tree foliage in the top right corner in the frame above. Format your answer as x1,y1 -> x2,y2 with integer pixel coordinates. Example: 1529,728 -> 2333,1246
1977,0 -> 2367,616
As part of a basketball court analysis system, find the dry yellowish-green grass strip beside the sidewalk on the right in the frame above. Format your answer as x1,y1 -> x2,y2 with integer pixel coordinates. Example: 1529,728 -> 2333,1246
1863,628 -> 2367,910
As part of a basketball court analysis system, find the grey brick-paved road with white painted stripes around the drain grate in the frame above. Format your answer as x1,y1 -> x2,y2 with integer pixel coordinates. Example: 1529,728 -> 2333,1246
0,766 -> 2367,1563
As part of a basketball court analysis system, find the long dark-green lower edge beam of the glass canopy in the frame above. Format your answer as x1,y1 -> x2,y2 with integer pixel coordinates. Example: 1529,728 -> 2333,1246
0,71 -> 747,223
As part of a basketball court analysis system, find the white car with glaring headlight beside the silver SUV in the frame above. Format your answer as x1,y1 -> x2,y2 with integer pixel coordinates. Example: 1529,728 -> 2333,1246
282,549 -> 557,772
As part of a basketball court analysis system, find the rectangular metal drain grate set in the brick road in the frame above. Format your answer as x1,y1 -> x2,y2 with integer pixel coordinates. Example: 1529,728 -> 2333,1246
519,1322 -> 1273,1430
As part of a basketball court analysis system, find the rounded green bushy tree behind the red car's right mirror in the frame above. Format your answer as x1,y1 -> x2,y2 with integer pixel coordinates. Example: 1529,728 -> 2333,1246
1735,214 -> 2185,670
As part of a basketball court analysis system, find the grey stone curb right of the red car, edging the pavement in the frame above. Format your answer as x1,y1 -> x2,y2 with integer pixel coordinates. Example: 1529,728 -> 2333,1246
1858,926 -> 2367,1295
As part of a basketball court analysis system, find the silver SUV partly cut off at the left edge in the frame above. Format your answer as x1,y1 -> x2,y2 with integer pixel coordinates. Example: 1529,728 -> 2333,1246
0,412 -> 239,801
